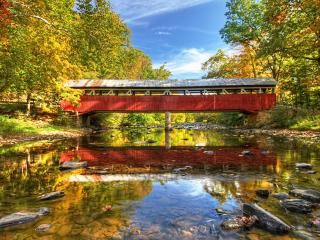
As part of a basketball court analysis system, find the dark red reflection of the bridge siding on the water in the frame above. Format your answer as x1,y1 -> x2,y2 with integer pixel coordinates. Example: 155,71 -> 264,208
60,146 -> 276,168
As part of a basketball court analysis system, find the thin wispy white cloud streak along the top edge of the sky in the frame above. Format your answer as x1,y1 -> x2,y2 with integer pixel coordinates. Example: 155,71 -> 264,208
111,0 -> 213,22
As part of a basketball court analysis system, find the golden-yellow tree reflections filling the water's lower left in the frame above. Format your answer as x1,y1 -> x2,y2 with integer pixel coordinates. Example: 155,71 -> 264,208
0,148 -> 152,239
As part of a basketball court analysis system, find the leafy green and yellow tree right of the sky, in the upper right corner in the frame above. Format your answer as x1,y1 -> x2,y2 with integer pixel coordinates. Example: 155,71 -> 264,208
220,0 -> 320,106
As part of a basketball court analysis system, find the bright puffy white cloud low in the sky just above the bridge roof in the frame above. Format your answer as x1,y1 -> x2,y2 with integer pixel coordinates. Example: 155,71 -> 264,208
155,48 -> 213,78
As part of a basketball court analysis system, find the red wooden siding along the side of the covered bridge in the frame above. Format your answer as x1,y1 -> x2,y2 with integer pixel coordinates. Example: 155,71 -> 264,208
61,94 -> 276,114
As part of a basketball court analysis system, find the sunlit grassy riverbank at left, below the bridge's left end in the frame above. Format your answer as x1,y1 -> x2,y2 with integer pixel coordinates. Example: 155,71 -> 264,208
0,116 -> 92,146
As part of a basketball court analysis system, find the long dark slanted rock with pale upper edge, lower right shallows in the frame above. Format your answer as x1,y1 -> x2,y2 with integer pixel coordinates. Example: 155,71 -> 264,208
243,203 -> 291,233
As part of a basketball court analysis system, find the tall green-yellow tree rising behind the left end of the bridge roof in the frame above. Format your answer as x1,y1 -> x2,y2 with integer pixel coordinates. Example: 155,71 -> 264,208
73,0 -> 130,79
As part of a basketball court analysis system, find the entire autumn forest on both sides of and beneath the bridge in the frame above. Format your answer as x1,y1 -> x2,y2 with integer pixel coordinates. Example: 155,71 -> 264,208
0,0 -> 320,130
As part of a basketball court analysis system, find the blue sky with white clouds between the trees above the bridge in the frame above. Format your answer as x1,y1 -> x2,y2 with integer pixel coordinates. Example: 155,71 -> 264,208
111,0 -> 228,79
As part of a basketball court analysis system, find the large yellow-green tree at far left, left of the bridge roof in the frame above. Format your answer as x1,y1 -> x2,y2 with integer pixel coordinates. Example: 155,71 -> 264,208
0,0 -> 78,114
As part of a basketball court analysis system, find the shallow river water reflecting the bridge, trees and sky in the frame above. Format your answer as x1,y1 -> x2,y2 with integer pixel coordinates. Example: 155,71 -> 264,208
0,129 -> 320,239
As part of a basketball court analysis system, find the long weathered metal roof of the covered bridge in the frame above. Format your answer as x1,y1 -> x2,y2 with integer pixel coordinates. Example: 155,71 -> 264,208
67,78 -> 276,89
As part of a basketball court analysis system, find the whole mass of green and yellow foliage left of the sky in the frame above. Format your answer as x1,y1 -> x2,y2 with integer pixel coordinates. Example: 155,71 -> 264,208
0,0 -> 170,114
